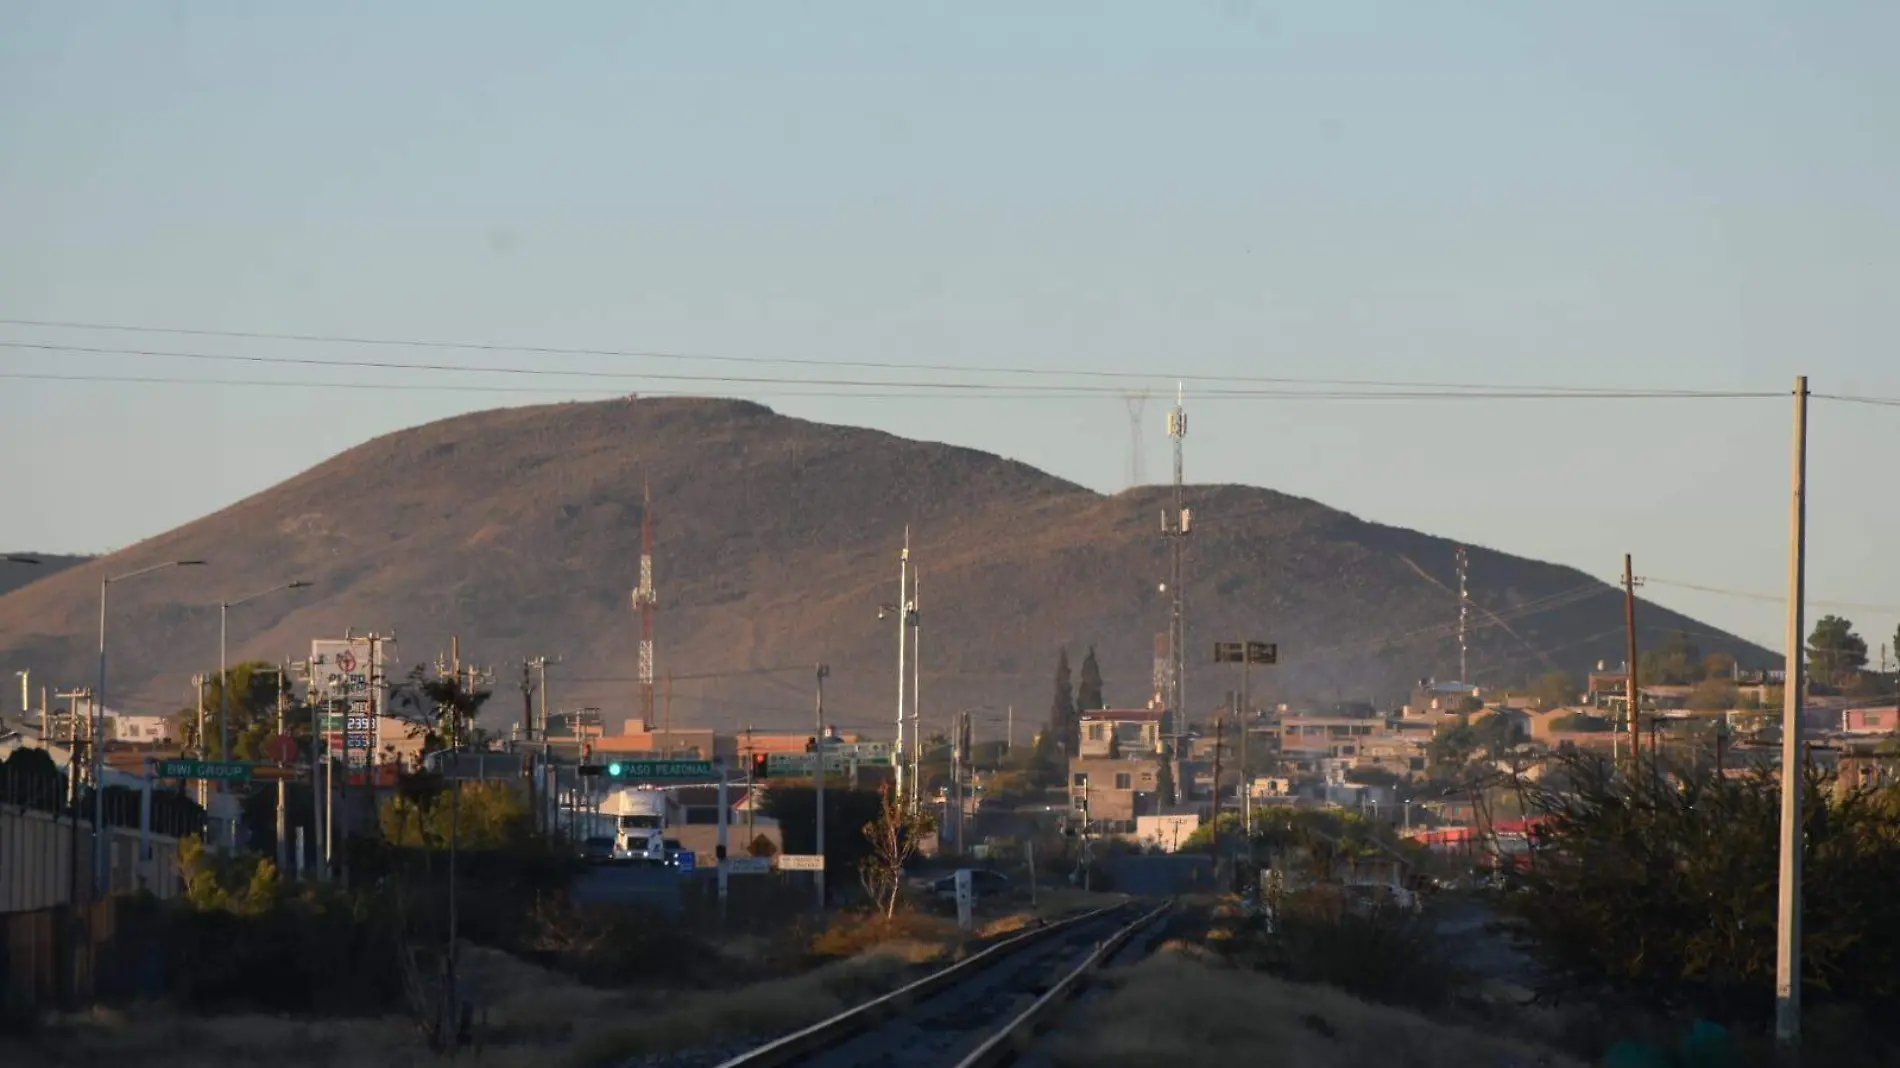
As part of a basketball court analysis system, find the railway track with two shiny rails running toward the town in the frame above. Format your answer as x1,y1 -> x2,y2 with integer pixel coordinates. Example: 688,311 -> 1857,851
720,903 -> 1172,1068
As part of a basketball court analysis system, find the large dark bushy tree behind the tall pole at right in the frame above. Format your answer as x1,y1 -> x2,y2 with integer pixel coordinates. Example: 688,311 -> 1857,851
1501,754 -> 1900,1020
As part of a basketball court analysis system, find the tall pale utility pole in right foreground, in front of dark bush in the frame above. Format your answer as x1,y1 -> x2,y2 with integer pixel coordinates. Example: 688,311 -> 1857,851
1775,374 -> 1807,1051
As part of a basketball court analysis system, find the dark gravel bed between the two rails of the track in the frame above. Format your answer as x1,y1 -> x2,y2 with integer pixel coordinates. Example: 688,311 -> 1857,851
710,905 -> 1155,1068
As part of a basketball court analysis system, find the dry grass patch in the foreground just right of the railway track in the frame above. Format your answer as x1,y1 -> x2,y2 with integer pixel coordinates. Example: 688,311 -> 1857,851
1053,943 -> 1583,1068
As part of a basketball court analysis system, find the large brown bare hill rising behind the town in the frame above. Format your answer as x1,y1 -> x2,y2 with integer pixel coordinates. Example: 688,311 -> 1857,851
0,399 -> 1769,737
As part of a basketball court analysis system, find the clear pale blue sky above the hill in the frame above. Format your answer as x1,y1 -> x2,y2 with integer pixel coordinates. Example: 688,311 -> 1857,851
0,0 -> 1900,648
